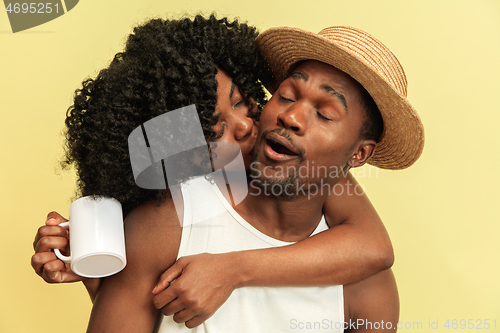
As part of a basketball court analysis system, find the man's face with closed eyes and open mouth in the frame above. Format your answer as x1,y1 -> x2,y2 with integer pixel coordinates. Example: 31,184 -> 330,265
251,61 -> 365,197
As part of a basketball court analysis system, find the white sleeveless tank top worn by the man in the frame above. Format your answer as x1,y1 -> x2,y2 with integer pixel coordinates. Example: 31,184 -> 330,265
159,177 -> 344,333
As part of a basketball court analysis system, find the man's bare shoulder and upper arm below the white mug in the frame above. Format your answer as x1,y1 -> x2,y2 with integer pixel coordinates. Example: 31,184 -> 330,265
87,201 -> 181,332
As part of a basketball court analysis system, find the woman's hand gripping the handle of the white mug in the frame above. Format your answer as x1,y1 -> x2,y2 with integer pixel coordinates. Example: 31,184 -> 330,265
31,212 -> 84,283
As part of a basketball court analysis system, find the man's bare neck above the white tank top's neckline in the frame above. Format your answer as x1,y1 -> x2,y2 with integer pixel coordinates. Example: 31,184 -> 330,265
235,187 -> 327,242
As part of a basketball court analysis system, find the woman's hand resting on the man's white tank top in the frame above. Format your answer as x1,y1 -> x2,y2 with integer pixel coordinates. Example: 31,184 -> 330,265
153,253 -> 239,328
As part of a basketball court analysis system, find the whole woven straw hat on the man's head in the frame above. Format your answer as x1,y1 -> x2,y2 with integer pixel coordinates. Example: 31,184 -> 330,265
255,27 -> 424,170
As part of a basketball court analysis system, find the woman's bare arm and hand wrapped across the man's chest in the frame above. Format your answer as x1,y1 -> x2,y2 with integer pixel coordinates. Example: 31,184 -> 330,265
155,174 -> 393,327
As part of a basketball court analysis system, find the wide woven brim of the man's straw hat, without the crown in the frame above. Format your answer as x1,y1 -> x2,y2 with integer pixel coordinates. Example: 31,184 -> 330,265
255,27 -> 424,170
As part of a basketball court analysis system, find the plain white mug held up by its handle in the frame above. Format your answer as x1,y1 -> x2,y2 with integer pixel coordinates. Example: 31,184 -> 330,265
54,196 -> 127,278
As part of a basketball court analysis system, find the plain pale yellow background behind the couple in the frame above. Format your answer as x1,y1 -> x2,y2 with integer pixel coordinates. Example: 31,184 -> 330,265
0,0 -> 500,333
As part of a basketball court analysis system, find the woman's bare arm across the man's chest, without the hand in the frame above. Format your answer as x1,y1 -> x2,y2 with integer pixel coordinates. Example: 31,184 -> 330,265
239,174 -> 394,286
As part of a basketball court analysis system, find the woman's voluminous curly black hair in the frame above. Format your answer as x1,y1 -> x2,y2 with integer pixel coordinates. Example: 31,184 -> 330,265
62,15 -> 268,214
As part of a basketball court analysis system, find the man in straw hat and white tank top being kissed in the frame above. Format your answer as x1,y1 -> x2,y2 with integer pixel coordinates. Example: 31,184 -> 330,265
85,24 -> 423,332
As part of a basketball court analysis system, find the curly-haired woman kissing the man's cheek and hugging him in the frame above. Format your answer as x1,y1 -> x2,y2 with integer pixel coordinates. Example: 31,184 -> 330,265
32,16 -> 392,327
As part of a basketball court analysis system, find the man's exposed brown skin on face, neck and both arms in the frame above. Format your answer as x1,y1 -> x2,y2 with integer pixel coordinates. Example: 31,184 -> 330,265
88,61 -> 399,332
